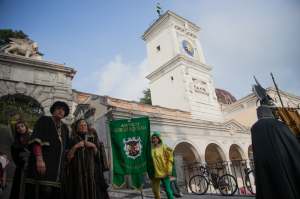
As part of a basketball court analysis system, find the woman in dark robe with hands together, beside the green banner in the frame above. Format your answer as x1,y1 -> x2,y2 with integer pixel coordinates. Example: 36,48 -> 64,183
65,119 -> 109,199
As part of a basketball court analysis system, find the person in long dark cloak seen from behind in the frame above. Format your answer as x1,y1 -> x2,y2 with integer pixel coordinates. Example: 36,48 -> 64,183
251,105 -> 300,199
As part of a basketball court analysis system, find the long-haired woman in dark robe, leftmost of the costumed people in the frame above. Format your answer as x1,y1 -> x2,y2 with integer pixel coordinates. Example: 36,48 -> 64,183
9,121 -> 35,199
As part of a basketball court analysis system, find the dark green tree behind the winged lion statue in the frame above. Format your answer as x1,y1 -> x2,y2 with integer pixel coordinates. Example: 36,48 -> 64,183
0,29 -> 44,56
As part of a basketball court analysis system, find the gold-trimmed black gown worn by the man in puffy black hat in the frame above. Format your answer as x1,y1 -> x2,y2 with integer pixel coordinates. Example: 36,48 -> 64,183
26,116 -> 69,188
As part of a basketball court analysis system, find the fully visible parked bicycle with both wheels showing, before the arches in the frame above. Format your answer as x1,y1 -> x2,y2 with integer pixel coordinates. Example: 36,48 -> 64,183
189,165 -> 238,196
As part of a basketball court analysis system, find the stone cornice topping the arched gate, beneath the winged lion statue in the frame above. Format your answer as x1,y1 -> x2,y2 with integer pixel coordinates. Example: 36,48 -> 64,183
0,53 -> 77,78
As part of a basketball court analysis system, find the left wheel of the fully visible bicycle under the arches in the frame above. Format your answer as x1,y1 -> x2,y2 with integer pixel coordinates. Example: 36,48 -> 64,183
189,175 -> 208,195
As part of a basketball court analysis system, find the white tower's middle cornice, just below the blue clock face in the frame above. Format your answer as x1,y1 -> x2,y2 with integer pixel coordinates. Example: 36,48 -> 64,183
146,54 -> 212,81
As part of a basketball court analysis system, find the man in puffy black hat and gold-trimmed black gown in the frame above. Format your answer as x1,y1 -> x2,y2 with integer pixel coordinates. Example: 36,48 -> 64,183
26,101 -> 70,199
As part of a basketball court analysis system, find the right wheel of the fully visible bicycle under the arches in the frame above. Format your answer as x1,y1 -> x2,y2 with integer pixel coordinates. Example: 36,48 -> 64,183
218,174 -> 238,196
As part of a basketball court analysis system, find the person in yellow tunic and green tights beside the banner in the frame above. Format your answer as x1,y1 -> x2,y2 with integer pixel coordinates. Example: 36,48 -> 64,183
151,132 -> 174,199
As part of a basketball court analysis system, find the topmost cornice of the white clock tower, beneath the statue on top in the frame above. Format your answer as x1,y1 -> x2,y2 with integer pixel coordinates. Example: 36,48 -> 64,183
141,11 -> 200,40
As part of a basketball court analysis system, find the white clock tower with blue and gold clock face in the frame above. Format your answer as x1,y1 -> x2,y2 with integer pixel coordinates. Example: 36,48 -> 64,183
141,11 -> 224,122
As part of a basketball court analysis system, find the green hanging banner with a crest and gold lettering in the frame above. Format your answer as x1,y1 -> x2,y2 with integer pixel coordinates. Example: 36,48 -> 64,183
109,117 -> 155,190
